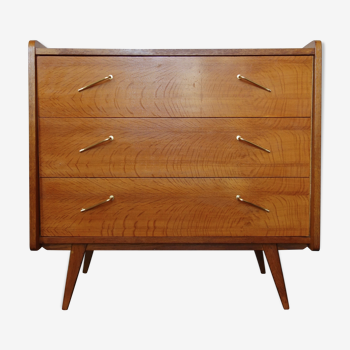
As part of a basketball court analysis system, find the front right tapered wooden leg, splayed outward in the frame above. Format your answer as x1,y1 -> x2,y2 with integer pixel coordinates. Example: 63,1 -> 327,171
263,244 -> 289,310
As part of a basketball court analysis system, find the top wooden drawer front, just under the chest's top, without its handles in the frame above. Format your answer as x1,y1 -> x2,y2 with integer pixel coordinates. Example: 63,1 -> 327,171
37,56 -> 313,118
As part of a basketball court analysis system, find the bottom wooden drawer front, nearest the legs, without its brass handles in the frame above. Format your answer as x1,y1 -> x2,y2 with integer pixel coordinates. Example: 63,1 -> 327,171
40,178 -> 309,237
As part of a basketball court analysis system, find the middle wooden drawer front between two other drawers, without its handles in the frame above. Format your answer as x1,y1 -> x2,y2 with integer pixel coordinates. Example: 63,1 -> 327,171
39,118 -> 310,177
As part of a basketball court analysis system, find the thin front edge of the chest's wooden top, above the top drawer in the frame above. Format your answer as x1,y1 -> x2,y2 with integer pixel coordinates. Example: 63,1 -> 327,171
36,47 -> 315,56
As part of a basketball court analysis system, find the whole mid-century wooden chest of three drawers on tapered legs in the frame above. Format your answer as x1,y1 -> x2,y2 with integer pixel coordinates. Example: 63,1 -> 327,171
29,41 -> 322,309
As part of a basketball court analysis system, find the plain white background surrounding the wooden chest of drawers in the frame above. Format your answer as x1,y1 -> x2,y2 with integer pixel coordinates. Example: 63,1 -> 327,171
0,0 -> 350,350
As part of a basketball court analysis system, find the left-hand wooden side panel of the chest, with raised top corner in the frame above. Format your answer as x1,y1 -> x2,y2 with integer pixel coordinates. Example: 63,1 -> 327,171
28,40 -> 44,250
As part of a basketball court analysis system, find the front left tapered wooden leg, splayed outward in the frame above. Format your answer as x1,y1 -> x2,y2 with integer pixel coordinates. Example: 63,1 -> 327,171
62,244 -> 86,310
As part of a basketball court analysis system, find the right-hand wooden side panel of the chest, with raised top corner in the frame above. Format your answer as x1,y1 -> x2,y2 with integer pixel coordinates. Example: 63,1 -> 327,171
307,40 -> 322,250
